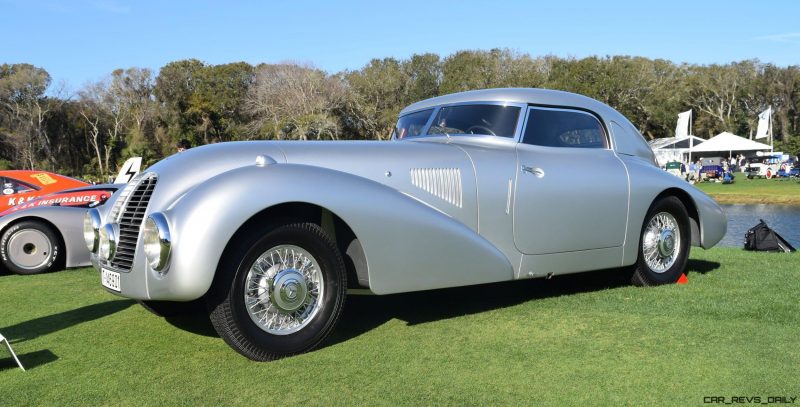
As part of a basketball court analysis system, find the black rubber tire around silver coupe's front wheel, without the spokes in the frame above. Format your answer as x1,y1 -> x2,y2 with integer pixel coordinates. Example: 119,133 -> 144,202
206,223 -> 347,361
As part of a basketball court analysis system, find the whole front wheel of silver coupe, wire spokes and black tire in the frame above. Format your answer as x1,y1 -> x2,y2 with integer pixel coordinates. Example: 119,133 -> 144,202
206,223 -> 347,361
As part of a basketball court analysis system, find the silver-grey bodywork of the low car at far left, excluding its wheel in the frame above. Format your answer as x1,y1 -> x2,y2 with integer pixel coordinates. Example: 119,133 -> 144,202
0,184 -> 119,267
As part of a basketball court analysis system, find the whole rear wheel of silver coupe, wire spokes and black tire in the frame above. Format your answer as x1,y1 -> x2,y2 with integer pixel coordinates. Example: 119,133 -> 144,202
632,196 -> 690,286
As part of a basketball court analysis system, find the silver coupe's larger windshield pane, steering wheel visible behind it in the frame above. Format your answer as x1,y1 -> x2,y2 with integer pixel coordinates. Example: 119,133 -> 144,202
428,105 -> 520,138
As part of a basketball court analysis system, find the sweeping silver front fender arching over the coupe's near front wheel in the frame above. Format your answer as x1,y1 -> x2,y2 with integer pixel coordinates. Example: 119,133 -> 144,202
148,164 -> 513,300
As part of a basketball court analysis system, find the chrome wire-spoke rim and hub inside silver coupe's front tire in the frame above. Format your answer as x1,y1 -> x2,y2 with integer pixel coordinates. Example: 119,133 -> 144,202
244,245 -> 324,335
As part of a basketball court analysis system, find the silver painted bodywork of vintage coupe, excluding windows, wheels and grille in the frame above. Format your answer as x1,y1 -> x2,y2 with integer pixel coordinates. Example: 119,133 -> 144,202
93,89 -> 726,301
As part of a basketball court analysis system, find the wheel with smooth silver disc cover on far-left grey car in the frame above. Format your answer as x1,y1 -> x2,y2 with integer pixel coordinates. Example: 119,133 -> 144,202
0,220 -> 66,275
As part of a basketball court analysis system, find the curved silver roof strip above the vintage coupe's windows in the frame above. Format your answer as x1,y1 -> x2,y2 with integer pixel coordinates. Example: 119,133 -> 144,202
400,88 -> 616,116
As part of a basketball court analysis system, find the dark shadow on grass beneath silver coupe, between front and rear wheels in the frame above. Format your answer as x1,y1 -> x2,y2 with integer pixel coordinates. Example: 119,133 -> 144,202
323,269 -> 630,347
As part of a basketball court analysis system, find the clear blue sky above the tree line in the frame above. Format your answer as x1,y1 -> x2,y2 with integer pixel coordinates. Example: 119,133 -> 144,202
0,0 -> 800,88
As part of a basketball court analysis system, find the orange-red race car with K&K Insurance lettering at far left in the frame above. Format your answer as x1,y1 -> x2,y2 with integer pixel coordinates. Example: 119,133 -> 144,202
0,170 -> 89,212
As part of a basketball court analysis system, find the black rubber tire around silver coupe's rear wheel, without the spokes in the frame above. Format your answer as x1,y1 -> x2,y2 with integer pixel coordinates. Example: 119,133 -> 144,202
631,196 -> 691,287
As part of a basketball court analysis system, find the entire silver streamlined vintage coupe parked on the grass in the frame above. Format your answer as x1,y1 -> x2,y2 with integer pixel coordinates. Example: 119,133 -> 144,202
84,89 -> 726,360
